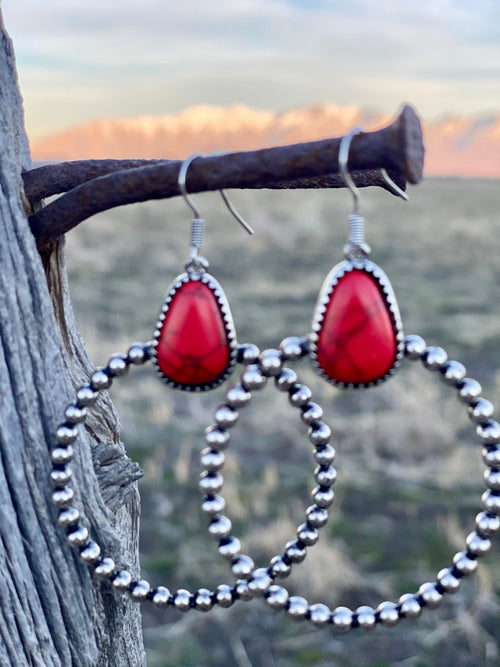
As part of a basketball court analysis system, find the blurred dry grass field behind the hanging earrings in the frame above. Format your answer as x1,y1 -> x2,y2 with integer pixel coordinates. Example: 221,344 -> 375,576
67,179 -> 500,667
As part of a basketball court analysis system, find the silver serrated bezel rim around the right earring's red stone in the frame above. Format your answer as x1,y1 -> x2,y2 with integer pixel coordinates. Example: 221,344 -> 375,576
309,258 -> 404,389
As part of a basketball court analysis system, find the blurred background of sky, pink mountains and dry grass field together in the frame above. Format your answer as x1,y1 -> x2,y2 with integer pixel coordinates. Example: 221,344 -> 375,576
2,0 -> 500,667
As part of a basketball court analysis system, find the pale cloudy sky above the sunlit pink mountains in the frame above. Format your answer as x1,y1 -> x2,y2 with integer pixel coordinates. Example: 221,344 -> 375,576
0,0 -> 500,140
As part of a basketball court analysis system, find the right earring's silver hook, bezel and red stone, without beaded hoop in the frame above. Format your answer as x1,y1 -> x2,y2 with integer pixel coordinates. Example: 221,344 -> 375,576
309,128 -> 408,388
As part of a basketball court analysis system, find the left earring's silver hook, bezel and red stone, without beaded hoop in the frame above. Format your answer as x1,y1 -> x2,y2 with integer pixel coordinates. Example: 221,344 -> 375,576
152,154 -> 253,391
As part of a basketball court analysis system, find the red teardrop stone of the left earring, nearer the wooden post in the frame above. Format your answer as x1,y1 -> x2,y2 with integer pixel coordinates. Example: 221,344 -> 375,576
156,280 -> 230,387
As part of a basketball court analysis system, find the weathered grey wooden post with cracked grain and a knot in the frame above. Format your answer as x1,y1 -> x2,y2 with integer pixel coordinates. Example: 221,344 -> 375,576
0,17 -> 145,667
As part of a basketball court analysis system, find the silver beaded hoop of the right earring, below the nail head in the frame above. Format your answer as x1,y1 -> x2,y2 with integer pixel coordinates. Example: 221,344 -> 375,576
202,336 -> 500,632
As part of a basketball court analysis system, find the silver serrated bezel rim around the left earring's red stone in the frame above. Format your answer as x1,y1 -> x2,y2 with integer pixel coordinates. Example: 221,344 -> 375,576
151,272 -> 238,392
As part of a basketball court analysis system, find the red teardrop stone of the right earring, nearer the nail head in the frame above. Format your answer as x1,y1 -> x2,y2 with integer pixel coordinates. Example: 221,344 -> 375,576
317,269 -> 397,384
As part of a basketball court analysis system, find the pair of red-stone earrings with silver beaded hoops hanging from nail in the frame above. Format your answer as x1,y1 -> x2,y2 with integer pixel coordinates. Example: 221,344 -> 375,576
50,130 -> 500,632
